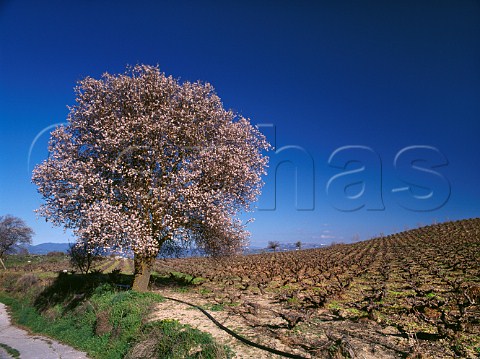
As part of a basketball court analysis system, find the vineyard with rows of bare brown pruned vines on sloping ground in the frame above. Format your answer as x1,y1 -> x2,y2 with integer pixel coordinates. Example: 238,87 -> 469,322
4,219 -> 480,358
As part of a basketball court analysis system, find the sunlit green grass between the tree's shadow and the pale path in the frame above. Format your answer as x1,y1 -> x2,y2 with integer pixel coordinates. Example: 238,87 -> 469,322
0,285 -> 160,359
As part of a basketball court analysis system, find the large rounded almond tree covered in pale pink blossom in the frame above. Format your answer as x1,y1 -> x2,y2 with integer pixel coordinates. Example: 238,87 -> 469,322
32,65 -> 269,291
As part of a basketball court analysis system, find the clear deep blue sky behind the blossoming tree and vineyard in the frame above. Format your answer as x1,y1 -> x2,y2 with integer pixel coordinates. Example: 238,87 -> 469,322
0,0 -> 480,245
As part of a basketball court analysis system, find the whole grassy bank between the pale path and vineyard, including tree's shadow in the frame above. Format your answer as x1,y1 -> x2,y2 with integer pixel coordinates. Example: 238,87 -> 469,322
0,273 -> 231,359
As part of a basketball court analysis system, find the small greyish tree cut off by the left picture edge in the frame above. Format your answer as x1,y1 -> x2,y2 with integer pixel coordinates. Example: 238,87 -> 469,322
0,214 -> 34,269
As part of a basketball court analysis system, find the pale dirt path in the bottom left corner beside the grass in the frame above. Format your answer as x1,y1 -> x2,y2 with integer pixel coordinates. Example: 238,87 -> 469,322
0,303 -> 88,359
